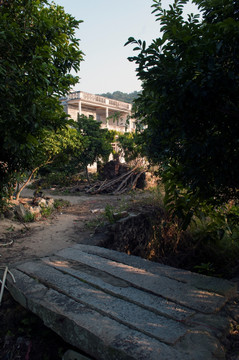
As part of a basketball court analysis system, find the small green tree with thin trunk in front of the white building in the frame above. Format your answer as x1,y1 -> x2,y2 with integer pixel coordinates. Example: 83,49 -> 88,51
75,115 -> 115,183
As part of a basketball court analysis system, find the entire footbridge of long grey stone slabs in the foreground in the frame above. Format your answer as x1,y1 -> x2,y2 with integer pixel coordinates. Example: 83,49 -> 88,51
8,245 -> 236,360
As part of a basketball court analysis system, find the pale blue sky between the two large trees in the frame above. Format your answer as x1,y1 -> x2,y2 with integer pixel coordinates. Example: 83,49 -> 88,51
54,0 -> 199,94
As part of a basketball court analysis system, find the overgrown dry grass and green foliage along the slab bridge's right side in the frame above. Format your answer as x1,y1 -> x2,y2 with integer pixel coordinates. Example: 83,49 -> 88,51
143,186 -> 239,278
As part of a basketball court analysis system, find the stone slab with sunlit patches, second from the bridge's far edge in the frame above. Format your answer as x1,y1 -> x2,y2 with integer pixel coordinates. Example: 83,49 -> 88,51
57,247 -> 230,314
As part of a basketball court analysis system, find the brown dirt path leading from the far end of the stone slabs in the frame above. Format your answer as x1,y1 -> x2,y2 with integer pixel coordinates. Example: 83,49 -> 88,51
0,189 -> 130,266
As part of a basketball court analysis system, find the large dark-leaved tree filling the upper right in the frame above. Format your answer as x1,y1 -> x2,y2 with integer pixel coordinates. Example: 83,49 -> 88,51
125,0 -> 239,203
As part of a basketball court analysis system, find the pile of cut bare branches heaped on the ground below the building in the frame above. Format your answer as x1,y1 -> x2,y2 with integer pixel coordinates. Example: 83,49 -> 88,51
86,165 -> 145,195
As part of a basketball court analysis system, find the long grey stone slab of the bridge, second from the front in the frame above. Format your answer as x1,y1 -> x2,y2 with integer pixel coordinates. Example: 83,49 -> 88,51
14,261 -> 187,344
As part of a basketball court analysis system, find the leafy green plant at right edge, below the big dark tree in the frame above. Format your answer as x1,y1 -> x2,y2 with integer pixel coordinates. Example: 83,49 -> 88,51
188,204 -> 239,277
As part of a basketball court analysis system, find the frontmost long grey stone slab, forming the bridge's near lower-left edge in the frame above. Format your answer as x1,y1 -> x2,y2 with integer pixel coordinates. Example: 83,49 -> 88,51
8,269 -> 190,360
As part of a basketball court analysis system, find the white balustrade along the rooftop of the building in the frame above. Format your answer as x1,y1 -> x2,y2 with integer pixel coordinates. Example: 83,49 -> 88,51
66,91 -> 131,111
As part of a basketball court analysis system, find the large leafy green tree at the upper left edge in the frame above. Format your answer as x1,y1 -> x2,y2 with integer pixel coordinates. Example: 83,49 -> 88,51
0,0 -> 82,202
